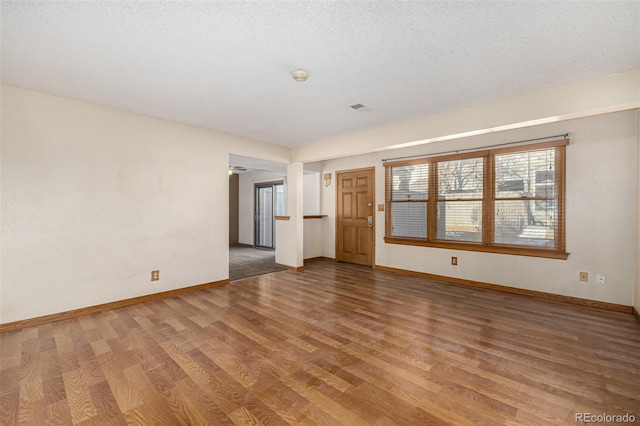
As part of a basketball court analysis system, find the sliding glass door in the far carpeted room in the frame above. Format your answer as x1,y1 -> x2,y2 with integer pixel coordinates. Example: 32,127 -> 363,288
254,181 -> 286,249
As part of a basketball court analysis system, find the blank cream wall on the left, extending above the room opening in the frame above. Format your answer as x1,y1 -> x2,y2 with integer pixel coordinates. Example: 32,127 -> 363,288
0,86 -> 290,323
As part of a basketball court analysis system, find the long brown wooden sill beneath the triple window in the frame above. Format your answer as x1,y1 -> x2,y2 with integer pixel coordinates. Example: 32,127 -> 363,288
384,237 -> 569,260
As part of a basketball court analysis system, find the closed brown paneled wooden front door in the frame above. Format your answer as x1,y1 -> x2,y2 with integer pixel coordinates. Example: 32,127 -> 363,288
336,168 -> 375,266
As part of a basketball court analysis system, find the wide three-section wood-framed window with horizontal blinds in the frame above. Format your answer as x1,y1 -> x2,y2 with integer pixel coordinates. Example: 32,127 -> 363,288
385,140 -> 568,259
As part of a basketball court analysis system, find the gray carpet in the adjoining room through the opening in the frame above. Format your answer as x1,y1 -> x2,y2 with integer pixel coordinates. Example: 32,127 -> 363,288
229,245 -> 284,281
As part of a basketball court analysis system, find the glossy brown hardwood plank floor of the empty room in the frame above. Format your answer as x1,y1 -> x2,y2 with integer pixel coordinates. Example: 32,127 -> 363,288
0,261 -> 640,425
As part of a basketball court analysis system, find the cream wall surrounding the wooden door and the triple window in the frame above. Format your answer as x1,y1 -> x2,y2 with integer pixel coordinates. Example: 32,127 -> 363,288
321,110 -> 639,306
